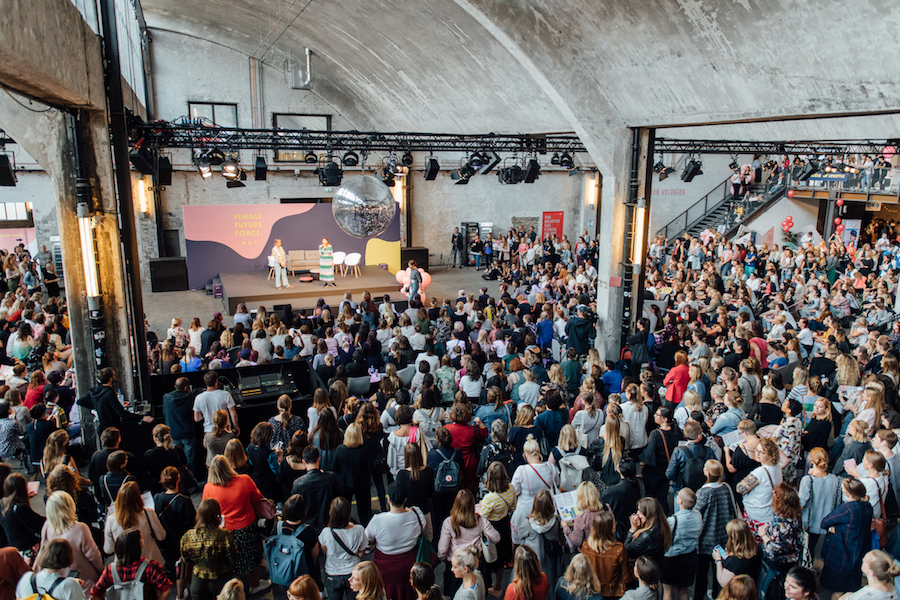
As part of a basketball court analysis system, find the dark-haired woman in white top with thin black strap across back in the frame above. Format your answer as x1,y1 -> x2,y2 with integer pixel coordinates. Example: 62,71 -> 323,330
319,497 -> 368,600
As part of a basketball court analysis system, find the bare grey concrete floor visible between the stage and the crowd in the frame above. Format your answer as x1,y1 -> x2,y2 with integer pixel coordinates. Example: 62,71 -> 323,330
143,266 -> 499,338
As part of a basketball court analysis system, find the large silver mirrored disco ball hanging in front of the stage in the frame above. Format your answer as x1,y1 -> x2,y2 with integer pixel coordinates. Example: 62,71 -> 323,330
331,175 -> 397,238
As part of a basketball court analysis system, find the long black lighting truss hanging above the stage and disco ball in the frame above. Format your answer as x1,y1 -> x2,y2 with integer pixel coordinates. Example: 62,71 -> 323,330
131,121 -> 587,154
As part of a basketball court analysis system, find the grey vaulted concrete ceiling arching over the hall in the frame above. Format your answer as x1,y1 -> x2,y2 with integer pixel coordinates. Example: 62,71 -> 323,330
142,0 -> 900,169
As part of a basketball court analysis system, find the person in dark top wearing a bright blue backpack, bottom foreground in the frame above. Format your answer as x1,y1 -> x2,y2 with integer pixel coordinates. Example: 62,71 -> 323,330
263,494 -> 322,598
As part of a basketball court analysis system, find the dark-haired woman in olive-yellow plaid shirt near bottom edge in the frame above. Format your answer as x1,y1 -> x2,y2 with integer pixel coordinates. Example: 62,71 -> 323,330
179,498 -> 237,600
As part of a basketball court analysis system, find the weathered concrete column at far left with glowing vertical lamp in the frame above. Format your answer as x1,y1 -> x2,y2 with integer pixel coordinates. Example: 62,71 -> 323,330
0,94 -> 132,397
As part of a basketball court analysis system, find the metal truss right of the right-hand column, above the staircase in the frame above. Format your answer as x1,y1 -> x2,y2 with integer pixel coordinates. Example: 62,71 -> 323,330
653,138 -> 897,155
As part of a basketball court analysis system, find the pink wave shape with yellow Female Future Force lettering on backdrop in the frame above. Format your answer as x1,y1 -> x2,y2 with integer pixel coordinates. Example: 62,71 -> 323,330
182,204 -> 315,259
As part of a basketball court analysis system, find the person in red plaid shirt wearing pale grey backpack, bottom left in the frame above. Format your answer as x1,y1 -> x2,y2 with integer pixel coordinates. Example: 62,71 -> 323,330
91,527 -> 172,600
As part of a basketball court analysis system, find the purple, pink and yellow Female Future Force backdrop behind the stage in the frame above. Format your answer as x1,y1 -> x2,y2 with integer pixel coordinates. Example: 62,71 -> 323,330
182,204 -> 400,290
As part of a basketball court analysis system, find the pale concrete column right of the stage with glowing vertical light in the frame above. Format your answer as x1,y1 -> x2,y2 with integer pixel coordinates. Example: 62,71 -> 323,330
592,128 -> 631,360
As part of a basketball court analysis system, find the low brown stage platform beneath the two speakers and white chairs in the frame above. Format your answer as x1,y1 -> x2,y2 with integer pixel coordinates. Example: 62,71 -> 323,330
219,266 -> 406,315
